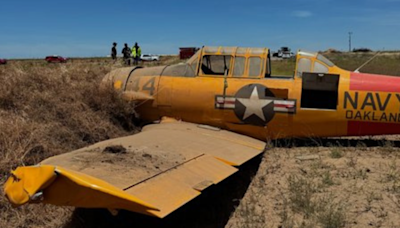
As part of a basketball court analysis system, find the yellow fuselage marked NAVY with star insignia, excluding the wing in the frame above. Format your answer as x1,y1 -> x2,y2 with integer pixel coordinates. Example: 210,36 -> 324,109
104,47 -> 400,140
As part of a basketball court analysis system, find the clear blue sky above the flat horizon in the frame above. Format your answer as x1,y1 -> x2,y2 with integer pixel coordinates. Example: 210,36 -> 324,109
0,0 -> 400,59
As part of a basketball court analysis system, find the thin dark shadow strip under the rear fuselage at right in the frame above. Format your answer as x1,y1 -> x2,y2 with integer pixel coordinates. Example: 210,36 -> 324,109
271,138 -> 400,148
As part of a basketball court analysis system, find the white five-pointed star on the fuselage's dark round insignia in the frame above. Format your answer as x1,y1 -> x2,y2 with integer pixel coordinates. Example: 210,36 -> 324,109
236,86 -> 273,121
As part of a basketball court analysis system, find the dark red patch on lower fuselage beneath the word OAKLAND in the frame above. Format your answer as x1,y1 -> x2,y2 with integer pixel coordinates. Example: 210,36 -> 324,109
347,121 -> 400,136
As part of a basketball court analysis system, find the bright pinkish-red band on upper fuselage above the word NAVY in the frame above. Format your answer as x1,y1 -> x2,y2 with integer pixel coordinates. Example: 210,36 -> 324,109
350,72 -> 400,92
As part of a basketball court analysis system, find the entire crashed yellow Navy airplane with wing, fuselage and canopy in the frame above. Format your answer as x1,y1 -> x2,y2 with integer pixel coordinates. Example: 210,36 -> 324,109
5,47 -> 400,218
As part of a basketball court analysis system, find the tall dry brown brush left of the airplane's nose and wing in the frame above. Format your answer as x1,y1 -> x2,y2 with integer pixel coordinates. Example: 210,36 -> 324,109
0,60 -> 138,227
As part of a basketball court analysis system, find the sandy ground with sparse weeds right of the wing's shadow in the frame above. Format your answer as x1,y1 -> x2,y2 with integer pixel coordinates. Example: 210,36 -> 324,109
226,136 -> 400,228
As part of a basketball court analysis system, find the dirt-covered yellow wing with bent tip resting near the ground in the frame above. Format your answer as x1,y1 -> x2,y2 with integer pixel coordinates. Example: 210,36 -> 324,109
5,120 -> 265,218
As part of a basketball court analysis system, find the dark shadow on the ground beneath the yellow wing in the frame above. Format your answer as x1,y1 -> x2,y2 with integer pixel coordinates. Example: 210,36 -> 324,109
64,155 -> 262,228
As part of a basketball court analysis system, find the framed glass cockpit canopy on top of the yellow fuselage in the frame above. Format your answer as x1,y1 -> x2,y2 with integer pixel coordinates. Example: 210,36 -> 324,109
129,46 -> 334,78
